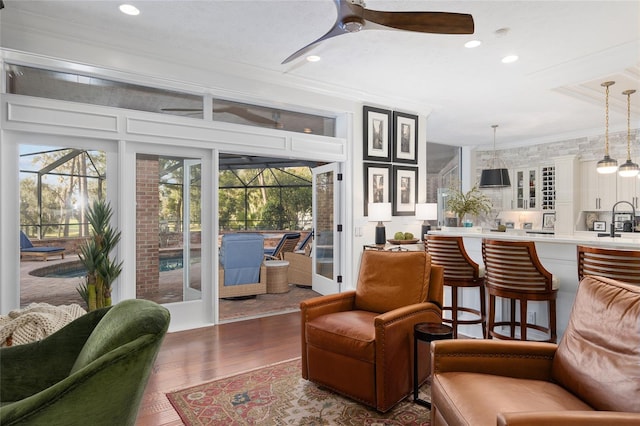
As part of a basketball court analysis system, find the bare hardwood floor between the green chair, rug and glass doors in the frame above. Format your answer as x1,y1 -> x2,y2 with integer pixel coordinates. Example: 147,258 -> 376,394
136,312 -> 300,426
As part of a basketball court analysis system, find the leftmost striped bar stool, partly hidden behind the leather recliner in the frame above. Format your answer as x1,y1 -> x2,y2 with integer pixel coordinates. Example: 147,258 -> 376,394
425,235 -> 487,339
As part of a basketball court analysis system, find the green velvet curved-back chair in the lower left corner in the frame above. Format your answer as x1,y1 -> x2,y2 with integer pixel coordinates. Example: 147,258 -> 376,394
0,300 -> 169,426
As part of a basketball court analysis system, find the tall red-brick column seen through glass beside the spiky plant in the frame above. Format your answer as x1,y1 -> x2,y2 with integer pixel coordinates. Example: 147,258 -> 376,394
136,155 -> 160,298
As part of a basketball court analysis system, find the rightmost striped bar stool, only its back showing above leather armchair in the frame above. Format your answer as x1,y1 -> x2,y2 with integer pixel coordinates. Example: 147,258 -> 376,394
578,245 -> 640,285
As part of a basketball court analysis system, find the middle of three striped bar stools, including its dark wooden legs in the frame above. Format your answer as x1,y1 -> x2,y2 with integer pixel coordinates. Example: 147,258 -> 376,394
482,239 -> 558,343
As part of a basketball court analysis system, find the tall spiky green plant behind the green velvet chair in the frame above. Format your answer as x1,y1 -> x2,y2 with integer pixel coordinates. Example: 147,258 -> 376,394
78,200 -> 122,311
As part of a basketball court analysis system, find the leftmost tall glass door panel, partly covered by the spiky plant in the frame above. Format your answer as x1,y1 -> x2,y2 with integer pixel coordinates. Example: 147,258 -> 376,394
15,142 -> 107,309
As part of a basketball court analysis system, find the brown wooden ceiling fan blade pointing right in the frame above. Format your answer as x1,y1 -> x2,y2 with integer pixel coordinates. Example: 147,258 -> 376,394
363,9 -> 474,34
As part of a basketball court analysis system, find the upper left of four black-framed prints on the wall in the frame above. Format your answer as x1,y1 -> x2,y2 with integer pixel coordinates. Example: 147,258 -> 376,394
362,106 -> 392,161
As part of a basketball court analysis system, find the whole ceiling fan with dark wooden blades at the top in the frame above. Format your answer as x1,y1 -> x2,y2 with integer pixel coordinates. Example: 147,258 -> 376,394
282,0 -> 474,64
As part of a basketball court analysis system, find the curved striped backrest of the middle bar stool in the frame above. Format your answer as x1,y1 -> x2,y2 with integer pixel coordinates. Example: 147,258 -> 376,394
482,239 -> 554,294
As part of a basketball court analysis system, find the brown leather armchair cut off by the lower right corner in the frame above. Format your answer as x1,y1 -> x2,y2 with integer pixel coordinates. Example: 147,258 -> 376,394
431,276 -> 640,426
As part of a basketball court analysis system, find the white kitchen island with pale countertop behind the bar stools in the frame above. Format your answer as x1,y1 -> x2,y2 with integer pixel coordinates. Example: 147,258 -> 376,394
429,228 -> 640,341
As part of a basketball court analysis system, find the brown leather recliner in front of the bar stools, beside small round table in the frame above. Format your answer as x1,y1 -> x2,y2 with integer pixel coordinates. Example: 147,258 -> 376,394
300,250 -> 443,412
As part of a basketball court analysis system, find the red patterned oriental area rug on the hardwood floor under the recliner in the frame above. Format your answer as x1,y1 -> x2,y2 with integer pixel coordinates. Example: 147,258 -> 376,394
167,358 -> 430,426
